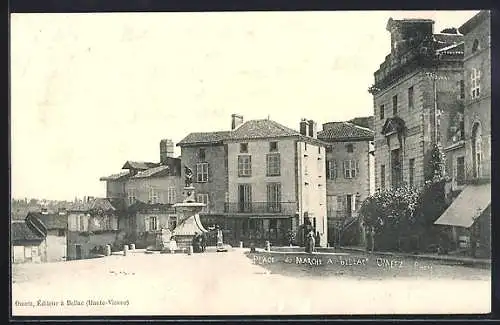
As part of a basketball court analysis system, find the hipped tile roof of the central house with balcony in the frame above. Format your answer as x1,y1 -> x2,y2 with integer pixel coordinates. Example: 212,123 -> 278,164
229,119 -> 301,140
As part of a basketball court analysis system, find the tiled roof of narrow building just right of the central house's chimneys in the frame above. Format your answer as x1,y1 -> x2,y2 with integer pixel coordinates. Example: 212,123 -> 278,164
318,122 -> 374,141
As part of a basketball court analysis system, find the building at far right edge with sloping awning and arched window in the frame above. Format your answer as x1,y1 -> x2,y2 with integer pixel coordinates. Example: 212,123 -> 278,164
436,11 -> 491,256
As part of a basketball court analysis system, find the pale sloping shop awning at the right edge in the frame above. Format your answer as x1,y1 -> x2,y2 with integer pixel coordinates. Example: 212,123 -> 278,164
434,183 -> 491,228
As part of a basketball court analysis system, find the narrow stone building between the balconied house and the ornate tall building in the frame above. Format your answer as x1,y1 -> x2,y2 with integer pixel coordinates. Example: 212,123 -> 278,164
318,122 -> 375,245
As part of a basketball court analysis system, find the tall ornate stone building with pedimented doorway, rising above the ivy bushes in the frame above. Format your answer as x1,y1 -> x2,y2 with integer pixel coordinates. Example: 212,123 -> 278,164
369,18 -> 463,189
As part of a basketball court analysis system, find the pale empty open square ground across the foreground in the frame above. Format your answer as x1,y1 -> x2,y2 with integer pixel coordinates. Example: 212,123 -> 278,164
12,249 -> 491,315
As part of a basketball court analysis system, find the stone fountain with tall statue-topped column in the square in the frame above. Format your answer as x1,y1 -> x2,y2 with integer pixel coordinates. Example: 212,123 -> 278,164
173,166 -> 208,250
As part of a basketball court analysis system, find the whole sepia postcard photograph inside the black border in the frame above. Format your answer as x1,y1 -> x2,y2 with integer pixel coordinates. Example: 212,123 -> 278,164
9,10 -> 492,317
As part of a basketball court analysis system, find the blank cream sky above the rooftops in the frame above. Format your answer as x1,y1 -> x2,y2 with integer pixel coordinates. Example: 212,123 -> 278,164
11,11 -> 477,200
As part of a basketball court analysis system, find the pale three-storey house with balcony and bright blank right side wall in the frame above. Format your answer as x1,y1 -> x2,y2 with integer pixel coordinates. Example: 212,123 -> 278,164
224,119 -> 327,246
